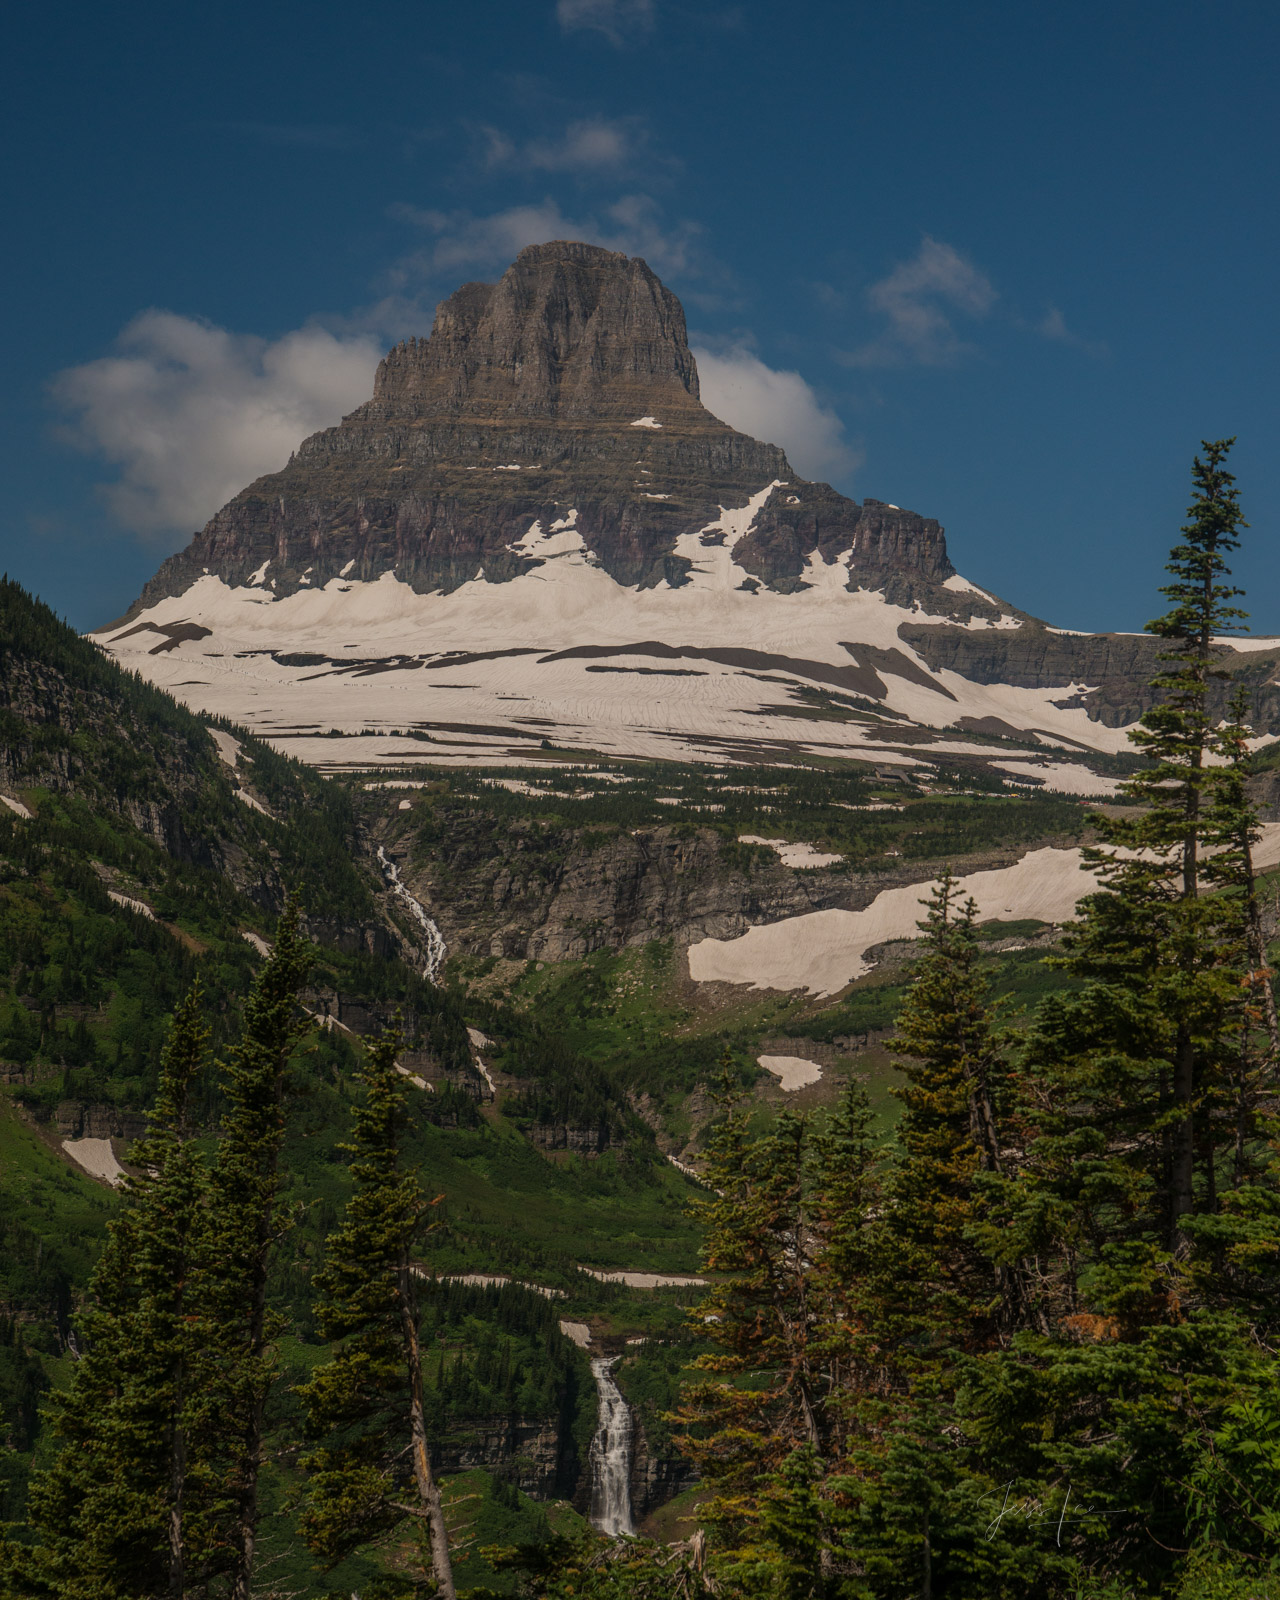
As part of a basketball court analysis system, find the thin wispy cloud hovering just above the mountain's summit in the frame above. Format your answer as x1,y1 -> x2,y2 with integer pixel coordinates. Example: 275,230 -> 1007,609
392,194 -> 702,290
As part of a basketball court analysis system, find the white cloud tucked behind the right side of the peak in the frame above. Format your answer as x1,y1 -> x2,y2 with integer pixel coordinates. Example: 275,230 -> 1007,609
693,344 -> 859,478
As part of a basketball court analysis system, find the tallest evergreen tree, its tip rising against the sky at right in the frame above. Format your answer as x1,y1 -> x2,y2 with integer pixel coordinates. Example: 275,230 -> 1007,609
960,442 -> 1280,1592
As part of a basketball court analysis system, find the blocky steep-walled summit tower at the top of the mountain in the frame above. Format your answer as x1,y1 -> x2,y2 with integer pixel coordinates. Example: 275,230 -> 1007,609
363,240 -> 704,429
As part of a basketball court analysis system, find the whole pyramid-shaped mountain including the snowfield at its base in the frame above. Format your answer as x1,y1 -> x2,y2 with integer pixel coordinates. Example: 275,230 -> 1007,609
98,242 -> 1280,774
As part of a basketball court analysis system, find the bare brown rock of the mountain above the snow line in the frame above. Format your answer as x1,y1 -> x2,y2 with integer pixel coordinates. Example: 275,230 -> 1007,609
131,242 -> 966,614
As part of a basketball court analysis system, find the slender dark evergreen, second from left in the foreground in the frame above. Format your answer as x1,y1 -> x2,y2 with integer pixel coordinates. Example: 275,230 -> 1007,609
195,898 -> 312,1600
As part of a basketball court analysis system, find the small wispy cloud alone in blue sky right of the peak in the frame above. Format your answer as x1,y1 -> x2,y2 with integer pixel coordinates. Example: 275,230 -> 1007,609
842,235 -> 997,366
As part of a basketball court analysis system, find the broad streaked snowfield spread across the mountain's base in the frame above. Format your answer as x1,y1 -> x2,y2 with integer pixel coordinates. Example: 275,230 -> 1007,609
93,483 -> 1126,774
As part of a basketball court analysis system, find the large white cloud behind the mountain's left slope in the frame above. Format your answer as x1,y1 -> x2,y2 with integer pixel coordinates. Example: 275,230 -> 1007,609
53,310 -> 382,544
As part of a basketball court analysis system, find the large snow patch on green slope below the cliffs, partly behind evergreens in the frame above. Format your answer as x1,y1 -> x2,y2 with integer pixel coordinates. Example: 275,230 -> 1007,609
690,846 -> 1096,995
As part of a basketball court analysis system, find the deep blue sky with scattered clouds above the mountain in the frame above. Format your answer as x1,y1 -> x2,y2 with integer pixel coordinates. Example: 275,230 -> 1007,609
0,0 -> 1280,632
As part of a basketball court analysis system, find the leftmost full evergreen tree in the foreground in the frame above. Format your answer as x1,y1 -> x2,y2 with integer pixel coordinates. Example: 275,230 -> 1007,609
8,986 -> 208,1600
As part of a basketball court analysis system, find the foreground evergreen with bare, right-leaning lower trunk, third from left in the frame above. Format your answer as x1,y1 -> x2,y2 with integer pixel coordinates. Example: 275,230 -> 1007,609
299,1034 -> 457,1600
